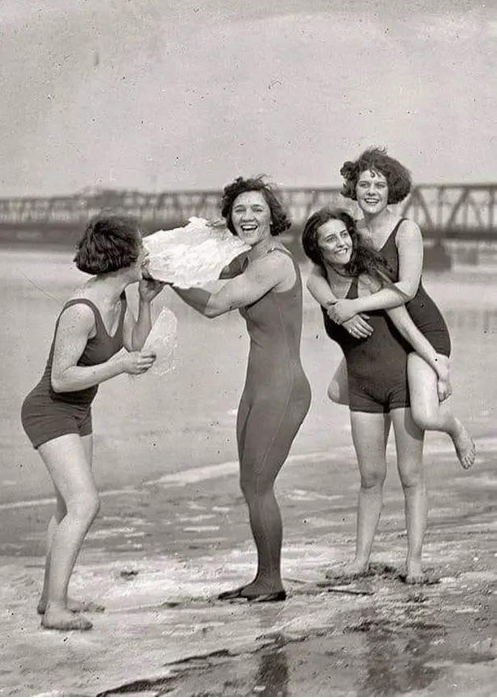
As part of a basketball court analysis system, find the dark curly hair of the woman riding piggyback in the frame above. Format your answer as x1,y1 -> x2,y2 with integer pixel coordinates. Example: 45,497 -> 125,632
340,148 -> 412,204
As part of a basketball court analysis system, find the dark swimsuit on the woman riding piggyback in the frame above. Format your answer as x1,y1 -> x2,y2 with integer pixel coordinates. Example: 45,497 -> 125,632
378,218 -> 450,356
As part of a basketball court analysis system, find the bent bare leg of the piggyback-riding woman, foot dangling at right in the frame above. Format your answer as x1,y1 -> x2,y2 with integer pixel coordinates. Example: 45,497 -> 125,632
407,353 -> 476,469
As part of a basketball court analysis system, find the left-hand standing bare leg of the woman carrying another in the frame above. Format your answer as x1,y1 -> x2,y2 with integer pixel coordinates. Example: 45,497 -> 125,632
326,412 -> 390,579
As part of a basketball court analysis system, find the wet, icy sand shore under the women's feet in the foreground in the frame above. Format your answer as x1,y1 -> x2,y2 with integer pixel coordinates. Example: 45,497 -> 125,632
0,438 -> 497,696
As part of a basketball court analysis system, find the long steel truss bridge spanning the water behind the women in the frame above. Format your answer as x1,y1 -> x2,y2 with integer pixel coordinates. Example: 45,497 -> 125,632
0,184 -> 497,242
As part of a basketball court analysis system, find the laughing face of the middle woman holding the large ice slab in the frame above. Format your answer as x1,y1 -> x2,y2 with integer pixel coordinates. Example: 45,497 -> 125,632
231,191 -> 271,247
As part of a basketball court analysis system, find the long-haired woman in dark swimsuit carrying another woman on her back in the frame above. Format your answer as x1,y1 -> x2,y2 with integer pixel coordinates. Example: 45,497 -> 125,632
302,208 -> 454,584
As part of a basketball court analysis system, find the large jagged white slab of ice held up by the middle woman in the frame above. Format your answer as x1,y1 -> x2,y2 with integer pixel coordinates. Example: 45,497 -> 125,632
143,217 -> 250,288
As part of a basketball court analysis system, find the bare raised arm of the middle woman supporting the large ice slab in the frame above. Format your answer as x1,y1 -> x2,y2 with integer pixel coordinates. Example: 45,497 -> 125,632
173,254 -> 286,318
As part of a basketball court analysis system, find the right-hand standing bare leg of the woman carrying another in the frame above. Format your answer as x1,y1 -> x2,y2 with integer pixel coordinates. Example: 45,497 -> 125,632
390,408 -> 428,584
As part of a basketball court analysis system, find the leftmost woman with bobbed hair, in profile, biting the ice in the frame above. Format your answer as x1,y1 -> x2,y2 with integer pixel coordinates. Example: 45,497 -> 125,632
21,215 -> 163,631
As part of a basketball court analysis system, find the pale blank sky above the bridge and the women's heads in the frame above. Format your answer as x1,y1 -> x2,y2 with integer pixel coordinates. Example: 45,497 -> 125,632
0,0 -> 497,197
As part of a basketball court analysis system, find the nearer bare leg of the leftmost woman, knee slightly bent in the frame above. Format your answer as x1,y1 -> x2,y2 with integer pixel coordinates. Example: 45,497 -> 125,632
39,434 -> 99,630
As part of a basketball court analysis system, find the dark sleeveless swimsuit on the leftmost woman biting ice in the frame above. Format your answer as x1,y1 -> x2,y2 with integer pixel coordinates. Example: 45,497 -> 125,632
21,293 -> 126,448
